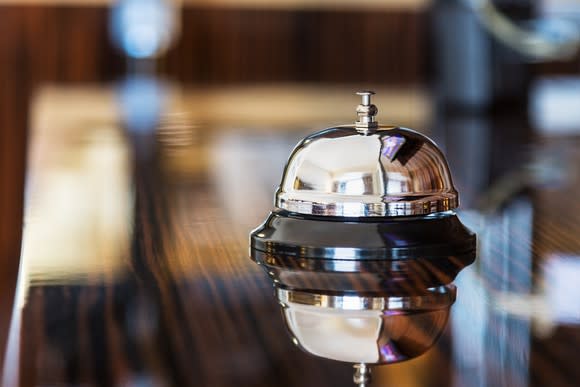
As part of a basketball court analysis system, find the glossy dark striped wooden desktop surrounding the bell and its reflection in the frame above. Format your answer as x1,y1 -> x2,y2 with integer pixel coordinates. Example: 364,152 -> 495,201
3,86 -> 580,387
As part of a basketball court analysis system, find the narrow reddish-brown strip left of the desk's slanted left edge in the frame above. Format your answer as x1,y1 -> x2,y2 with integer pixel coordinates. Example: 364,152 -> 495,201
0,6 -> 29,382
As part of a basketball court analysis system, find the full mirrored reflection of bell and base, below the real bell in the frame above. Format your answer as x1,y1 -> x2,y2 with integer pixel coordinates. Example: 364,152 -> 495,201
251,239 -> 468,386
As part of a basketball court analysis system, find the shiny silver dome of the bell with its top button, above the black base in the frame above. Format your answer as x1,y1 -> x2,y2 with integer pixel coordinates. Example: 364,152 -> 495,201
276,91 -> 459,217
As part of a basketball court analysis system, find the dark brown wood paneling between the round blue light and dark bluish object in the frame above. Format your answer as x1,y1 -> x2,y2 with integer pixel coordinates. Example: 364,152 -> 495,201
163,8 -> 427,84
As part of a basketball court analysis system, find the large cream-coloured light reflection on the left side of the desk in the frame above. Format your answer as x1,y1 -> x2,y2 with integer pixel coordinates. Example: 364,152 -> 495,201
22,91 -> 133,283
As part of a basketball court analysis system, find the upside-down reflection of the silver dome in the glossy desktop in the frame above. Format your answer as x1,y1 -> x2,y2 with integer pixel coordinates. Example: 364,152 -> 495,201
277,285 -> 456,364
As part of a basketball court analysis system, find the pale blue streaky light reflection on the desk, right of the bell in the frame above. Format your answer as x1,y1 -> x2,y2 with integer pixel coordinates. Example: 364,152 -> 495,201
451,197 -> 534,387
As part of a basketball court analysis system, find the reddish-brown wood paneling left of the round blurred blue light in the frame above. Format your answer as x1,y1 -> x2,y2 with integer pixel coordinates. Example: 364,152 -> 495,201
0,6 -> 123,86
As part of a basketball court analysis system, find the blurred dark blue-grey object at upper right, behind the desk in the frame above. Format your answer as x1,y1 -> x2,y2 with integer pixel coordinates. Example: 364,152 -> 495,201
433,0 -> 533,113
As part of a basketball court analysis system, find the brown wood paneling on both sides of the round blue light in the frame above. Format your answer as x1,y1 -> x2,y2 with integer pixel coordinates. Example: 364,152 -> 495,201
0,6 -> 427,84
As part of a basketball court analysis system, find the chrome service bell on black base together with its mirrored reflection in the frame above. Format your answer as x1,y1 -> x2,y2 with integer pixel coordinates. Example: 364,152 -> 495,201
250,91 -> 476,384
